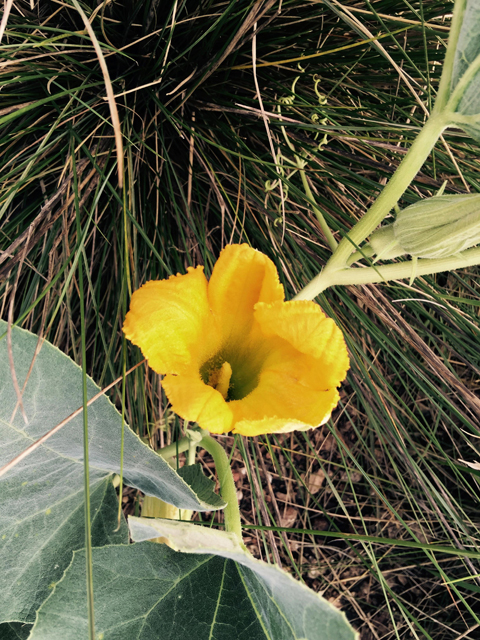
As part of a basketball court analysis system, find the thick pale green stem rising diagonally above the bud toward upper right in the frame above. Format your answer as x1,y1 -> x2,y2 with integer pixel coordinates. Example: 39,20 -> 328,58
318,114 -> 448,276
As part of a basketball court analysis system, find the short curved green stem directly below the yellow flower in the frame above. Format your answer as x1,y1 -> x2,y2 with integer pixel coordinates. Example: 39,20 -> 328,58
198,435 -> 242,543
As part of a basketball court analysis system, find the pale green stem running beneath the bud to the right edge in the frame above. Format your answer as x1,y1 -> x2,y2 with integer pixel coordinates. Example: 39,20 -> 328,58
294,247 -> 480,300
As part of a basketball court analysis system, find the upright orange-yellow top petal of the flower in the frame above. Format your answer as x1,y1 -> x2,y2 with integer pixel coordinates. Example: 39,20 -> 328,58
208,244 -> 285,343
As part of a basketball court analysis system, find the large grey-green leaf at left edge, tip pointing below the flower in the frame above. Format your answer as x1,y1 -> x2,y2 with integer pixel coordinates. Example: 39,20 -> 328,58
0,321 -> 221,622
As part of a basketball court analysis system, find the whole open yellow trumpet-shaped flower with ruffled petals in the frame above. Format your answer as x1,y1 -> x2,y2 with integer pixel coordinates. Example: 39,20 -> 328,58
123,244 -> 349,436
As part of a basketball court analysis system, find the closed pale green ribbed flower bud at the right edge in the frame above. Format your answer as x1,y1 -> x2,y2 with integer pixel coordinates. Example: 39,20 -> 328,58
369,194 -> 480,260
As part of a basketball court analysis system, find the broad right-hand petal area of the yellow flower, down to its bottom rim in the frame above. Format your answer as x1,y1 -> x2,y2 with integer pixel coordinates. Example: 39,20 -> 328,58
231,301 -> 349,435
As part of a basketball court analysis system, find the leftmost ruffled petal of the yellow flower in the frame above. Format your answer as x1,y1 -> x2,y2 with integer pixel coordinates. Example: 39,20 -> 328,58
123,267 -> 215,373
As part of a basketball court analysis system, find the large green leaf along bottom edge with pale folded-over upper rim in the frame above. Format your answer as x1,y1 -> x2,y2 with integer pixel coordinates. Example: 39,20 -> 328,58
31,519 -> 356,640
